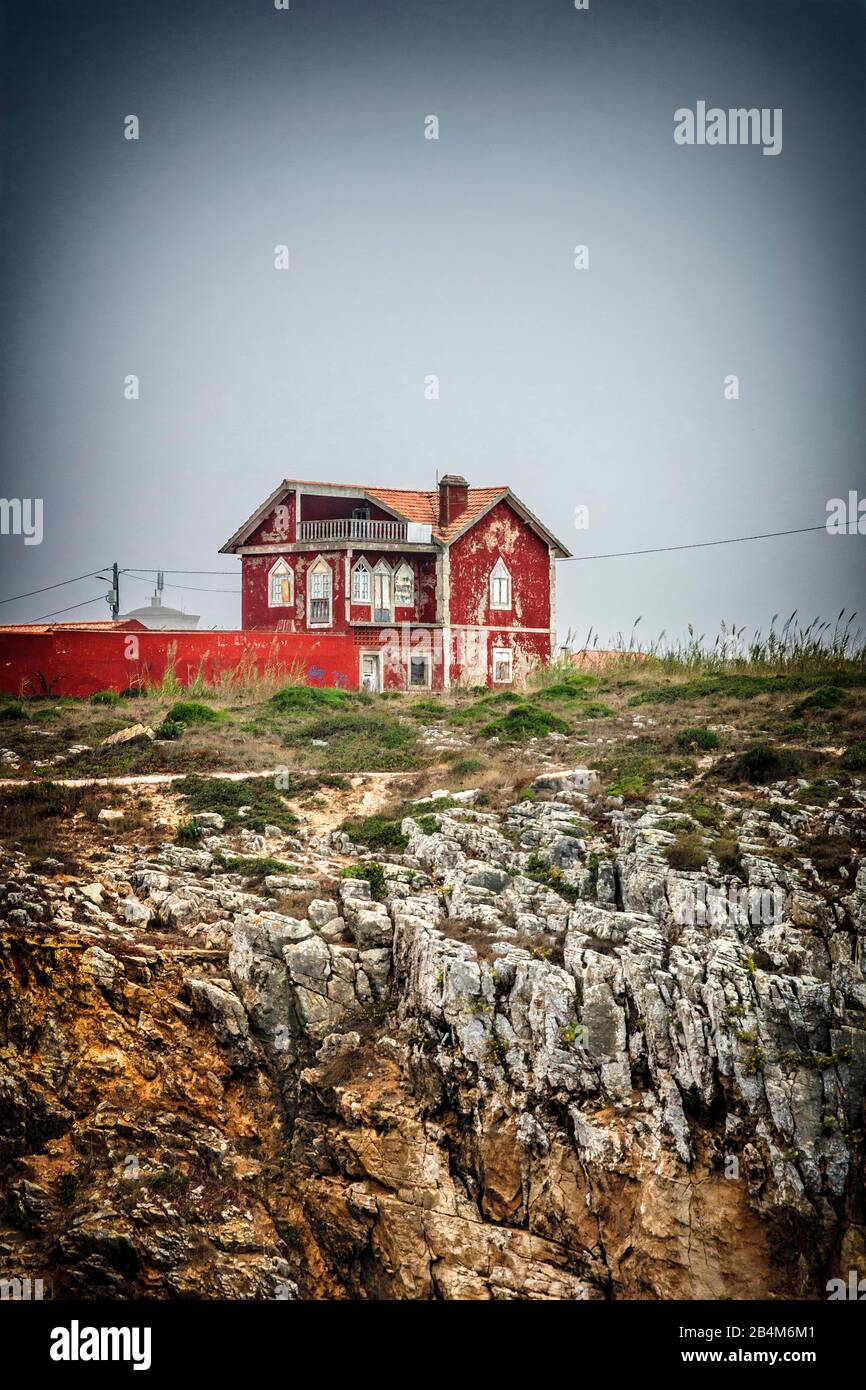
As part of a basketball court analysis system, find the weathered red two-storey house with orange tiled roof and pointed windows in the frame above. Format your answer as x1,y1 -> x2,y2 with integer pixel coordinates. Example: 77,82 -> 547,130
221,474 -> 569,689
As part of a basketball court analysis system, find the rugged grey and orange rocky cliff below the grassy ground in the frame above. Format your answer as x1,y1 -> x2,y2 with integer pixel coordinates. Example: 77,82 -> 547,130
0,770 -> 866,1300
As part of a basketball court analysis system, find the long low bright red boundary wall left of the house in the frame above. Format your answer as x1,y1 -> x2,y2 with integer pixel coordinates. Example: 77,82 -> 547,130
0,624 -> 359,696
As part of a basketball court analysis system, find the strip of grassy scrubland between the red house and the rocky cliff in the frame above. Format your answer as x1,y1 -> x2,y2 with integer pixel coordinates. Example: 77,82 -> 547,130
0,619 -> 866,823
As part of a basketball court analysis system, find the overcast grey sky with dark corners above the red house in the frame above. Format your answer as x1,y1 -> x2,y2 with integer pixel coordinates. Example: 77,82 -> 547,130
0,0 -> 866,641
